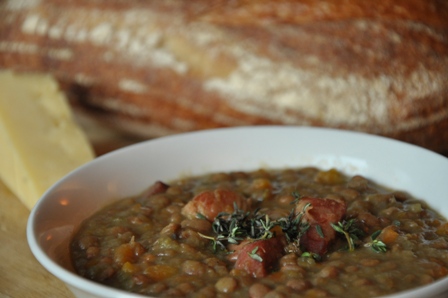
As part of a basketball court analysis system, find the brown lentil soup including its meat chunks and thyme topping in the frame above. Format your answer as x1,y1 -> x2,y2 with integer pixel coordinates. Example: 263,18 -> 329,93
71,167 -> 448,297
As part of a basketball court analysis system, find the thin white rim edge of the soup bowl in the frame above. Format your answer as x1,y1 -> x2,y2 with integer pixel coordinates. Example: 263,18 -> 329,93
26,125 -> 448,298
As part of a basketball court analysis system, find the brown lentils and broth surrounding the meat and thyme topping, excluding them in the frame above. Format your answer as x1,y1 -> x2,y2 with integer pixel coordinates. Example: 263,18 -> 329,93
71,168 -> 448,297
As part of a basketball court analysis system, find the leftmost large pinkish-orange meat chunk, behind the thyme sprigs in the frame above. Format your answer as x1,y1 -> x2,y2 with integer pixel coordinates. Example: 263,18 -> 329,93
182,188 -> 248,221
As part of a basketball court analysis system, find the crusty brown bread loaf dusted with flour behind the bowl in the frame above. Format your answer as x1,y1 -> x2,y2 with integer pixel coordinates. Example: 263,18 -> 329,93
0,0 -> 448,151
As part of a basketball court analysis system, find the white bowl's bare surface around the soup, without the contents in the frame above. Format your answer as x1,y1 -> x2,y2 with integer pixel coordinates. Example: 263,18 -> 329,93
27,126 -> 448,298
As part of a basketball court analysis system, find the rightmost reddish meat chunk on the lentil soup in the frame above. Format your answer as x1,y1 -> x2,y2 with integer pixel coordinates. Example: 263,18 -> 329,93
296,197 -> 347,255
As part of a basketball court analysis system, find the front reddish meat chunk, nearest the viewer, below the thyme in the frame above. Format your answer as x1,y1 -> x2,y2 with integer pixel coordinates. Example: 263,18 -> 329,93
229,235 -> 286,278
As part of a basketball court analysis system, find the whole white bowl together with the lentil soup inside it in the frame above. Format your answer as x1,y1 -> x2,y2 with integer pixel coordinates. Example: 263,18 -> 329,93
28,126 -> 448,297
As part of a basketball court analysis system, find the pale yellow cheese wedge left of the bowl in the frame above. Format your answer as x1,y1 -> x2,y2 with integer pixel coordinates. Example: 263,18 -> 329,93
0,70 -> 94,210
